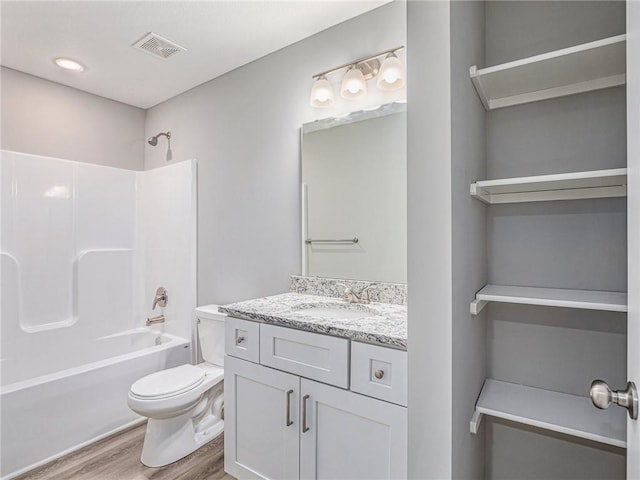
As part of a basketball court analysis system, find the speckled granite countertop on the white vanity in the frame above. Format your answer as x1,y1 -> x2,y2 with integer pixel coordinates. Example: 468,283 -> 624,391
218,292 -> 407,350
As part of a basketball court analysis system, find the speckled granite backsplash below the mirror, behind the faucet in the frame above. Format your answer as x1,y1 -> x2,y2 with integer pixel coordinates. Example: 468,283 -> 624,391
289,275 -> 407,305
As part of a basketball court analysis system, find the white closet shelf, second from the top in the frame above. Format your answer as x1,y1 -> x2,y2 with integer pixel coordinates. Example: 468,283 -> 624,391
470,168 -> 627,204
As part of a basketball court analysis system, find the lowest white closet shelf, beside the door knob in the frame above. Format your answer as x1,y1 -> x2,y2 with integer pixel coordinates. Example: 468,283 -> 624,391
470,378 -> 627,448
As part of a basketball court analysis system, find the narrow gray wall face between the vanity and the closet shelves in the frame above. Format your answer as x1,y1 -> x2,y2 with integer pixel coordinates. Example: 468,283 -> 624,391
407,1 -> 452,480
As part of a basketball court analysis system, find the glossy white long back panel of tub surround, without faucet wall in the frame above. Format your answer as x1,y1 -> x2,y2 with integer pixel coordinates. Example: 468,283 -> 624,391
0,151 -> 138,385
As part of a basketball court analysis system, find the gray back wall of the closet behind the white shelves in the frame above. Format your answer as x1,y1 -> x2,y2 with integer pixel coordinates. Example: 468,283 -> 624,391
481,2 -> 627,479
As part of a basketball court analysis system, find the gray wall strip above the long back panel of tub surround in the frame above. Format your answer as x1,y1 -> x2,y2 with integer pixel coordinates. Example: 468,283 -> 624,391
0,67 -> 145,170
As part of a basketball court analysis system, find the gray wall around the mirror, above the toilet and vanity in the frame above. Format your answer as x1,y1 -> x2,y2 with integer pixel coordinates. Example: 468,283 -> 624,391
145,2 -> 406,304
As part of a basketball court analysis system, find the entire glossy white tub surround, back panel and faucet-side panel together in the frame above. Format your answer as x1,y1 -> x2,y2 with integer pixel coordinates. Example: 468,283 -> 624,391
0,151 -> 196,385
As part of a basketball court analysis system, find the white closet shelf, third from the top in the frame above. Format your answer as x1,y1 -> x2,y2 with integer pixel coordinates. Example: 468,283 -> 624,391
470,285 -> 627,315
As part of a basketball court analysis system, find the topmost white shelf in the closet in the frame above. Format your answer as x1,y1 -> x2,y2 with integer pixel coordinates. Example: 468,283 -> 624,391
469,35 -> 626,110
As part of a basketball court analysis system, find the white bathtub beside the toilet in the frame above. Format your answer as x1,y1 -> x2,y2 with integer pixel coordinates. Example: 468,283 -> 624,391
0,328 -> 191,480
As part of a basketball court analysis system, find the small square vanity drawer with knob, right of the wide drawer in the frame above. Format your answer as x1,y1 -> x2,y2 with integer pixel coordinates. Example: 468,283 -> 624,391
351,342 -> 407,406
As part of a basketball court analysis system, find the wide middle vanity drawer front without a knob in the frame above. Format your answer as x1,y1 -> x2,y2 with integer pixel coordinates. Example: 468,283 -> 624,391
260,323 -> 349,388
